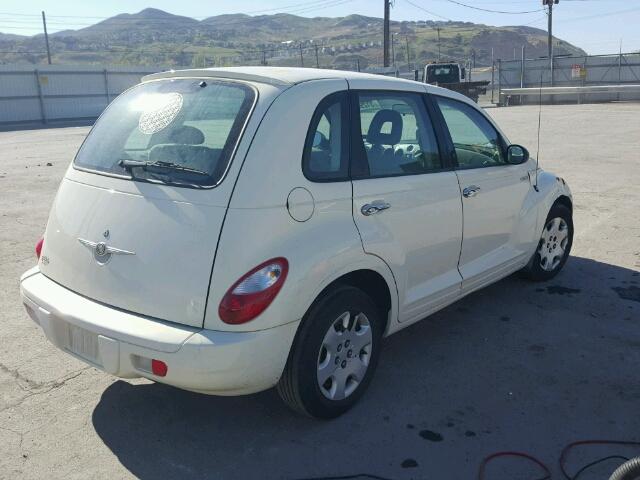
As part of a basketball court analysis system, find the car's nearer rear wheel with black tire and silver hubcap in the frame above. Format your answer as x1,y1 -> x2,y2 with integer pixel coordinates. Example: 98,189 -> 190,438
278,286 -> 383,419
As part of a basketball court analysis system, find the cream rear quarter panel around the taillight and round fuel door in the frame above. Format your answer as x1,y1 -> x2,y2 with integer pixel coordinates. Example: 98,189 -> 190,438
204,79 -> 397,331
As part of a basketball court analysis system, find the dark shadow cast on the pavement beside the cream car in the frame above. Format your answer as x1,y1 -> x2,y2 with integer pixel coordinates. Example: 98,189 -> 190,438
92,257 -> 640,479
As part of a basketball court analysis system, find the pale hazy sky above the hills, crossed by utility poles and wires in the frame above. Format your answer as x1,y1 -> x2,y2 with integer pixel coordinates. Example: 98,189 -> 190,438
0,0 -> 640,54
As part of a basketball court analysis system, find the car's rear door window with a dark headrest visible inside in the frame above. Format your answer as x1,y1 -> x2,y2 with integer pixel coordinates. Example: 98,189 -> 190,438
358,93 -> 442,177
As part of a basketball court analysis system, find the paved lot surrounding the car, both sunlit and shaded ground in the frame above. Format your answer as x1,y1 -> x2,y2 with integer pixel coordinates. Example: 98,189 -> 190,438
0,104 -> 640,480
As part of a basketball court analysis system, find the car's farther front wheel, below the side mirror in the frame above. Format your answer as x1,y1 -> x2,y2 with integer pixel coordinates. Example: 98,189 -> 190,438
522,204 -> 573,282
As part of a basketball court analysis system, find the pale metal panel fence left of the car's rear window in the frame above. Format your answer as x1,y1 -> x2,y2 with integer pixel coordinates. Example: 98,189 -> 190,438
0,65 -> 162,127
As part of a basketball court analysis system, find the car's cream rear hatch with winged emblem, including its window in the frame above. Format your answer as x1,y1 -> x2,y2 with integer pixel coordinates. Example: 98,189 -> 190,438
40,78 -> 257,327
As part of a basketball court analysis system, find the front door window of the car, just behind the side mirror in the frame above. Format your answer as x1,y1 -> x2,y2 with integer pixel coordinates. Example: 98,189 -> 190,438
434,97 -> 507,168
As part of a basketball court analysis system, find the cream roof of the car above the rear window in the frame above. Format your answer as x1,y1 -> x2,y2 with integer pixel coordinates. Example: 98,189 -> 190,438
142,67 -> 428,88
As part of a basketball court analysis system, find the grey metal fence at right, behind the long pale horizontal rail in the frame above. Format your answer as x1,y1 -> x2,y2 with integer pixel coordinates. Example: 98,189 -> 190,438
496,53 -> 640,103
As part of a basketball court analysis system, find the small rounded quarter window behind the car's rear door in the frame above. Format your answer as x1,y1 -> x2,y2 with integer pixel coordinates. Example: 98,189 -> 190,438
302,92 -> 349,182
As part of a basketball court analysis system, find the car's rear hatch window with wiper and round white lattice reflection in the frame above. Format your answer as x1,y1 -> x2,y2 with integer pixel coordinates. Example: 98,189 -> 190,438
75,79 -> 255,187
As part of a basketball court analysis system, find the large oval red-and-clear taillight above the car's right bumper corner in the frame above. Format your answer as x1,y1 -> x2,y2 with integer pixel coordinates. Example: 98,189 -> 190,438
218,257 -> 289,325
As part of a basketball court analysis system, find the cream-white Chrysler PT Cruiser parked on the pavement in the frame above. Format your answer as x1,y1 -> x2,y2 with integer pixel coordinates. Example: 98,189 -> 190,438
21,67 -> 573,418
